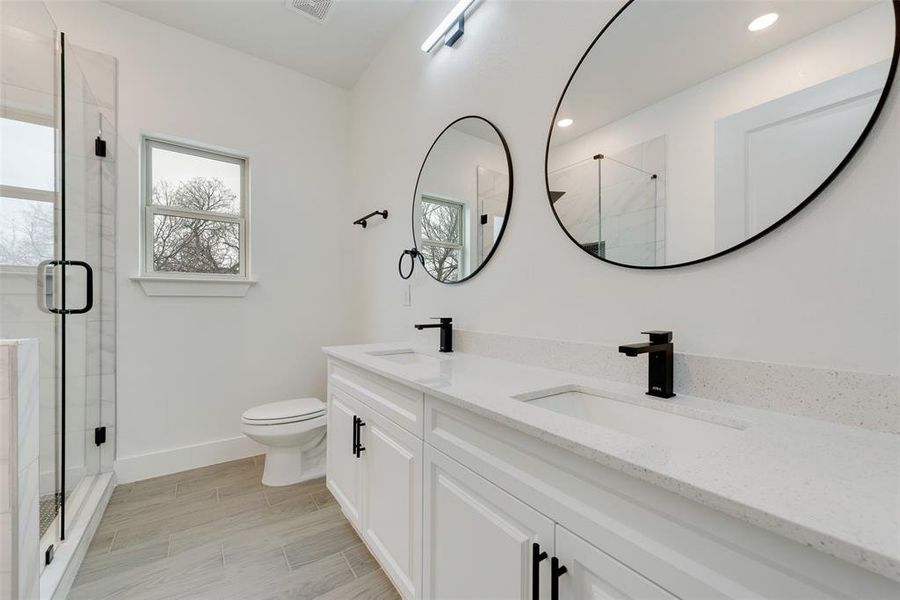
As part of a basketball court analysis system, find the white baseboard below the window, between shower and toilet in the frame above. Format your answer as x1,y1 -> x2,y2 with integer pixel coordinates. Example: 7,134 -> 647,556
115,435 -> 265,483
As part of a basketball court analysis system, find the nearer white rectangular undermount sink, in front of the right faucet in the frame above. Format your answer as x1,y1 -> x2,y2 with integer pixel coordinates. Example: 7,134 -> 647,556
513,385 -> 749,446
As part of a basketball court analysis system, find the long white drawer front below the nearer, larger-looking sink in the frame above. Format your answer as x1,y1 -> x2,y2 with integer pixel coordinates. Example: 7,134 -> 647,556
425,396 -> 900,600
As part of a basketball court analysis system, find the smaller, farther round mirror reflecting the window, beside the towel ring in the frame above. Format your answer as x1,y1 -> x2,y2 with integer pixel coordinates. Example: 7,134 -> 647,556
412,117 -> 512,283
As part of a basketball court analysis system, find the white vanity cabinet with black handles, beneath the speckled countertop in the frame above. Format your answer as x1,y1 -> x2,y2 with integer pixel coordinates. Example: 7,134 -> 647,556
327,360 -> 900,600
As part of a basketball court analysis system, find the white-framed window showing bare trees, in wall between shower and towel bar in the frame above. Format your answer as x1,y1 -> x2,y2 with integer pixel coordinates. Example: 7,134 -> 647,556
143,138 -> 248,279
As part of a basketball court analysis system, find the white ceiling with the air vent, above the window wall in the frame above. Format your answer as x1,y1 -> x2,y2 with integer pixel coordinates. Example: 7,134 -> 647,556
106,0 -> 414,88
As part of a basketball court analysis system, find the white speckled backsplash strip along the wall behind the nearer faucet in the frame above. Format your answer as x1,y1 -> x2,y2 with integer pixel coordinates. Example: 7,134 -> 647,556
454,331 -> 900,433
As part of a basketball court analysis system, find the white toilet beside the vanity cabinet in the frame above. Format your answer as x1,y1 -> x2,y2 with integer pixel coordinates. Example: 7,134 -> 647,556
241,398 -> 325,486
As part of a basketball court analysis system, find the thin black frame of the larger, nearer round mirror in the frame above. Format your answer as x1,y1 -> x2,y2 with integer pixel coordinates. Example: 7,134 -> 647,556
544,0 -> 900,271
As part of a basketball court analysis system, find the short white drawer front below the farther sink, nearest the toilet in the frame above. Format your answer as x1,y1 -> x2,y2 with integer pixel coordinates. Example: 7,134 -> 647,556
328,360 -> 424,439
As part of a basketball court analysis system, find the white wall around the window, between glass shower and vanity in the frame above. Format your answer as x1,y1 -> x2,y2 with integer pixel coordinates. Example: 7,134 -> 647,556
49,2 -> 352,480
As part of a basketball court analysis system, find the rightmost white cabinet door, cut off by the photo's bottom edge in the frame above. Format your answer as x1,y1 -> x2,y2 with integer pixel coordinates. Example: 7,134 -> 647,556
556,525 -> 676,600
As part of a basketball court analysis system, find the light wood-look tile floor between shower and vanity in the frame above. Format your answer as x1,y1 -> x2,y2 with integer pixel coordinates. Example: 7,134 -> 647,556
69,456 -> 399,600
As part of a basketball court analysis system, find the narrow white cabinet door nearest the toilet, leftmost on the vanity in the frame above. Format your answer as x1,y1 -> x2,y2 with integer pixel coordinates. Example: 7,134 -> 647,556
326,386 -> 362,530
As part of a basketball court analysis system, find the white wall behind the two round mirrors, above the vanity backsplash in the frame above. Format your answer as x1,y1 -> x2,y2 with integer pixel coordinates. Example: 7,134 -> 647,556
349,2 -> 900,374
